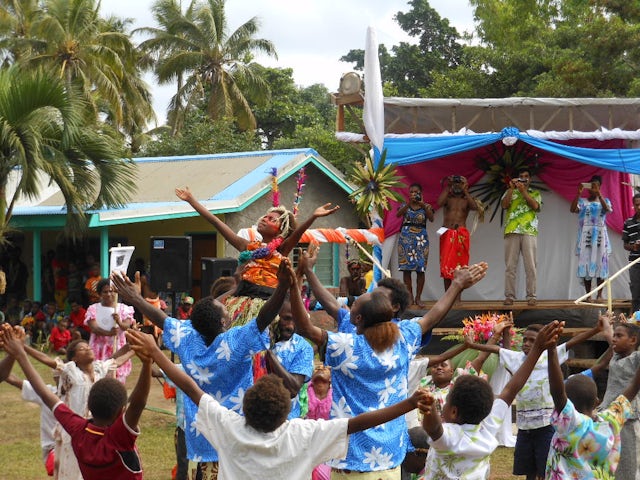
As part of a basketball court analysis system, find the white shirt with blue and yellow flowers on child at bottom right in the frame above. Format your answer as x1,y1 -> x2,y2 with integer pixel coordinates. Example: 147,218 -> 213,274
545,395 -> 631,480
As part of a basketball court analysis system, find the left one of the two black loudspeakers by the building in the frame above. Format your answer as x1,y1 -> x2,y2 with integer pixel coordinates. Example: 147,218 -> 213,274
149,237 -> 192,292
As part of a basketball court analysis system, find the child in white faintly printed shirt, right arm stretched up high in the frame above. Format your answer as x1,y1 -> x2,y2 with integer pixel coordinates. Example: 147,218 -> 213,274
419,321 -> 562,479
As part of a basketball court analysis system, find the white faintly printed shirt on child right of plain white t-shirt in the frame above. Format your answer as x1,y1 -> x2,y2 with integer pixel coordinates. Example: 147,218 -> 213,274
422,398 -> 509,480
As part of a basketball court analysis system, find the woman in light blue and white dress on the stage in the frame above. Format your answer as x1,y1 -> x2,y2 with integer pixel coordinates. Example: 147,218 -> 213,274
571,175 -> 613,300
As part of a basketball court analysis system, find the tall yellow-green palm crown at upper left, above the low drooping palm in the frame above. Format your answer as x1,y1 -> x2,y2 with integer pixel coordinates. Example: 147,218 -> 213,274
26,0 -> 153,133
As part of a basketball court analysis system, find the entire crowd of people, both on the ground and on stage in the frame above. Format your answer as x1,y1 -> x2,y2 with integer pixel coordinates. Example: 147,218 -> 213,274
0,177 -> 640,480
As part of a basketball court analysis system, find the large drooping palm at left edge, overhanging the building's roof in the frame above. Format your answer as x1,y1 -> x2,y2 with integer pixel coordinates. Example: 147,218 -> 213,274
0,67 -> 135,239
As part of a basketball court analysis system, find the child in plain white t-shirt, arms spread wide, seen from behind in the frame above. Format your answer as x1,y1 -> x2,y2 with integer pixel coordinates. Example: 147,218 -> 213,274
126,331 -> 426,480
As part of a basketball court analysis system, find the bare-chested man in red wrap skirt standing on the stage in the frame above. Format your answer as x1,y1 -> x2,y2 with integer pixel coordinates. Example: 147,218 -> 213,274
438,175 -> 478,290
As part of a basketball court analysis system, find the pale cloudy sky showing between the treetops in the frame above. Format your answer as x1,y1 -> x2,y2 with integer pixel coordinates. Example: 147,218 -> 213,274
101,0 -> 473,123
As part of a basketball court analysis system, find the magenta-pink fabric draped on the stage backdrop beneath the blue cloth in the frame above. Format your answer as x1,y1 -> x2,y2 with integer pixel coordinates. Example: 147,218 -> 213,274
384,139 -> 634,237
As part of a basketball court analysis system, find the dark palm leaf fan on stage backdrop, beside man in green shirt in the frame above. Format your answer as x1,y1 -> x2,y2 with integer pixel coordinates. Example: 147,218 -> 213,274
470,142 -> 548,225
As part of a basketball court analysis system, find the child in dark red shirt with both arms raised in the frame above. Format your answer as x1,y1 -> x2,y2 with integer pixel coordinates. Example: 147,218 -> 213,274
0,325 -> 152,480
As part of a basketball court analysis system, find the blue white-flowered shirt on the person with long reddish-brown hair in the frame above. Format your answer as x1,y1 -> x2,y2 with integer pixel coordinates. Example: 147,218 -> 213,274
324,320 -> 422,472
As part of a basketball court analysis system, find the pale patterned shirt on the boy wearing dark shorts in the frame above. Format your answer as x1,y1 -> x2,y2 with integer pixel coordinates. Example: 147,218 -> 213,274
500,343 -> 568,430
